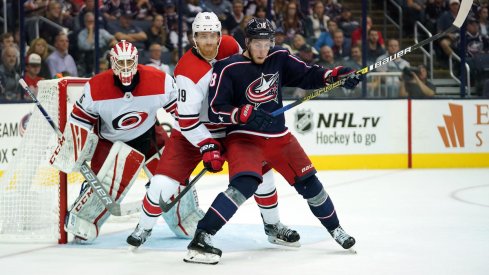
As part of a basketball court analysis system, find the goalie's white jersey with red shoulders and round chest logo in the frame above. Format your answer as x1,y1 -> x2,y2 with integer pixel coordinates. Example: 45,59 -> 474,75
69,65 -> 177,142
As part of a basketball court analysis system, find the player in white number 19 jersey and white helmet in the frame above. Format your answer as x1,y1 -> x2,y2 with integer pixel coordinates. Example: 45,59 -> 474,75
127,12 -> 300,247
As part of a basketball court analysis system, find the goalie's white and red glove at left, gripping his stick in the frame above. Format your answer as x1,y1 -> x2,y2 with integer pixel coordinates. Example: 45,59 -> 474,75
49,123 -> 98,173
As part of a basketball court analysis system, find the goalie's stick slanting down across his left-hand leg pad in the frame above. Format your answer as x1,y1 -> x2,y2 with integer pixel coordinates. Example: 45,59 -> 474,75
19,78 -> 129,216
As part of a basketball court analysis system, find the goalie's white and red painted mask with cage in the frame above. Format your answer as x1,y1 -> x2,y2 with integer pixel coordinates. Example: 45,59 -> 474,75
110,40 -> 138,86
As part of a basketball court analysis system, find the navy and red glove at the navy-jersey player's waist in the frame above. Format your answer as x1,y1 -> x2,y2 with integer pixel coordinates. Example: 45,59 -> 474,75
234,104 -> 274,131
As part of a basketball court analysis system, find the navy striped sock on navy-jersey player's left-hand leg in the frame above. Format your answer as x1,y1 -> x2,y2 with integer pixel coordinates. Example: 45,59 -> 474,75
197,176 -> 259,235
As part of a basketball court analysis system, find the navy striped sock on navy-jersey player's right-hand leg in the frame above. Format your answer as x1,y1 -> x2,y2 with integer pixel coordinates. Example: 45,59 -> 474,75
294,175 -> 340,231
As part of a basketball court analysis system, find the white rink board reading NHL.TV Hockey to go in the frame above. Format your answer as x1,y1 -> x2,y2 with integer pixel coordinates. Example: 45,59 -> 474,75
284,100 -> 408,169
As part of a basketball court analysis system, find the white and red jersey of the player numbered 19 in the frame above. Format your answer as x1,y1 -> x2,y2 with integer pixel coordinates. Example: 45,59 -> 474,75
174,35 -> 242,146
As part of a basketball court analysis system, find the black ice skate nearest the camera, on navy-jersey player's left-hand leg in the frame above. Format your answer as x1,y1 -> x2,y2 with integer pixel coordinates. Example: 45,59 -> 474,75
183,229 -> 222,264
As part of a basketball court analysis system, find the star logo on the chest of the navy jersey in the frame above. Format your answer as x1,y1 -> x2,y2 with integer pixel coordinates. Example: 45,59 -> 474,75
246,72 -> 278,106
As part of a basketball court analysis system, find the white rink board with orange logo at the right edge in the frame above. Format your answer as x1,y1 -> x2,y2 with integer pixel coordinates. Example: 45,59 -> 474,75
412,100 -> 489,167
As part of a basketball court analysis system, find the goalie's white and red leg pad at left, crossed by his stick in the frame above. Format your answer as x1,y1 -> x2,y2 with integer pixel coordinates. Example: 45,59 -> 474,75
65,141 -> 144,241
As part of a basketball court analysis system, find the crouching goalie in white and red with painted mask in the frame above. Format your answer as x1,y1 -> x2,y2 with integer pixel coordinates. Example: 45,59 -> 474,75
51,40 -> 177,241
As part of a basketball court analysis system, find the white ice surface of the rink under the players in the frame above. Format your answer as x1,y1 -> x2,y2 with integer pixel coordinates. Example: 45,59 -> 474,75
0,169 -> 489,275
